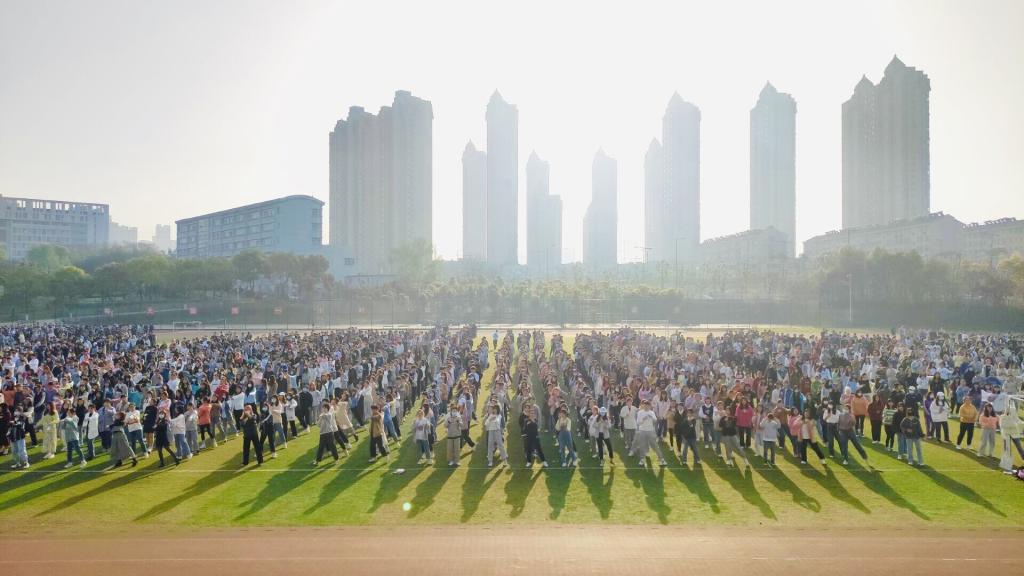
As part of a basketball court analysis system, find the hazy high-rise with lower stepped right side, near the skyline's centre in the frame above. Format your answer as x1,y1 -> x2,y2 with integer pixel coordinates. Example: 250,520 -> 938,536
526,152 -> 562,274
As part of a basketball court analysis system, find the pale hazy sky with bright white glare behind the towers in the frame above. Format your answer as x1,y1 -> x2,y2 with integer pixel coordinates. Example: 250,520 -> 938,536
0,0 -> 1024,261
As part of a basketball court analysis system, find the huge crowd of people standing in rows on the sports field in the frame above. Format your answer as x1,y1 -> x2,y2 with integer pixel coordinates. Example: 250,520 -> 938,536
0,324 -> 1024,477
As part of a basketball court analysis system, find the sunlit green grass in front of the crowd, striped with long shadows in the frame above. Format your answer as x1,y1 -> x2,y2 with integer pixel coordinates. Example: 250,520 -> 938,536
0,337 -> 1024,531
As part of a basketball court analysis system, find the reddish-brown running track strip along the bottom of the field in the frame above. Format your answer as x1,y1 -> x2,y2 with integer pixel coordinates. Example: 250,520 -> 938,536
0,526 -> 1024,576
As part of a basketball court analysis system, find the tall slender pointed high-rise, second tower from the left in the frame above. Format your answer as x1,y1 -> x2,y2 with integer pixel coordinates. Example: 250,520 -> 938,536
486,90 -> 519,265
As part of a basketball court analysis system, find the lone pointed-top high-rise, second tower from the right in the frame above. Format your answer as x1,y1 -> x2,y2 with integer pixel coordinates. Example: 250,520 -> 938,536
751,82 -> 797,258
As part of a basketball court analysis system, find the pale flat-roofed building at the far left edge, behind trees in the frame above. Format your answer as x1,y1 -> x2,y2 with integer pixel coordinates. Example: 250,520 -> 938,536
0,196 -> 111,260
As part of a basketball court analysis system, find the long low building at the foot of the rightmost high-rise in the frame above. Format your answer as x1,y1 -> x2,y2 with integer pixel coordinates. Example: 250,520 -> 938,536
804,212 -> 964,259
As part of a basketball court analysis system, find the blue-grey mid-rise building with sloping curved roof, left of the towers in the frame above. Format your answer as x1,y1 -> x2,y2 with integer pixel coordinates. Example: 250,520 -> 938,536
176,196 -> 324,258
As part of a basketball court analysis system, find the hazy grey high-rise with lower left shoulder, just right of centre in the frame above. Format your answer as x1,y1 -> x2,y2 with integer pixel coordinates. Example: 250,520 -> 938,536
583,150 -> 618,268
